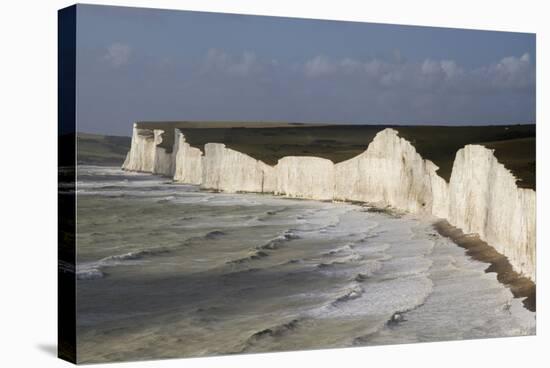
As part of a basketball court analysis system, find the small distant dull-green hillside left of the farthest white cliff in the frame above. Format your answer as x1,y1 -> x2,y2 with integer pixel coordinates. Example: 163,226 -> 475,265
77,133 -> 132,166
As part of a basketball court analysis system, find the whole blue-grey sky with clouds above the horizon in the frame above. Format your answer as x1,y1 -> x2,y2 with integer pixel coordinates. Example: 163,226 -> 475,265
77,5 -> 536,136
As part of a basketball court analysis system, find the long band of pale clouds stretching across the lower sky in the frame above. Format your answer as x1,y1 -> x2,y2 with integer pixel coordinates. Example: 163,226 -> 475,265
79,43 -> 536,133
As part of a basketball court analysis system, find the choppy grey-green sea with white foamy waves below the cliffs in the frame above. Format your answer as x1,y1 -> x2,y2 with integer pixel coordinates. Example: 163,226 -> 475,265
76,166 -> 536,363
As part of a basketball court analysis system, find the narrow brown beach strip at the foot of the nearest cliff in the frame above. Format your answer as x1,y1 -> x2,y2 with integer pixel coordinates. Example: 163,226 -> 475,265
433,220 -> 537,312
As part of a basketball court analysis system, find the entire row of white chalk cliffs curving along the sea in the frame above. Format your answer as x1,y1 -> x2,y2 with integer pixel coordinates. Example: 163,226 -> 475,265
123,124 -> 536,281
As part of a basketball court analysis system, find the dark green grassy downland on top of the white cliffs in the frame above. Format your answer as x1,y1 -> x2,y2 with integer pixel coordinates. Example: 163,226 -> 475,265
174,123 -> 536,189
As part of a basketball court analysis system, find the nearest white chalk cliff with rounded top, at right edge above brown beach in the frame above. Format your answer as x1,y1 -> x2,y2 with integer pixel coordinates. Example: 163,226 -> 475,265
447,145 -> 536,280
